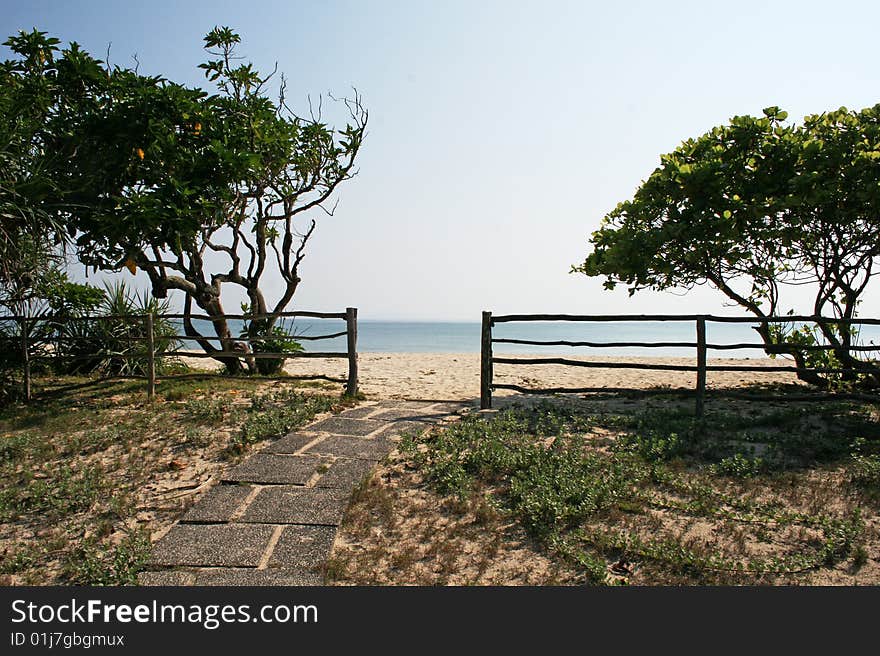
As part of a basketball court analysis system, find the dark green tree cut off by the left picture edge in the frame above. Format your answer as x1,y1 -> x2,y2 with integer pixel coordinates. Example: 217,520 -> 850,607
0,30 -> 96,402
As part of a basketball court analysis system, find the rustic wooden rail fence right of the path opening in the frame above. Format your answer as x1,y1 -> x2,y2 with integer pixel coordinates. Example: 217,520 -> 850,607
480,312 -> 880,416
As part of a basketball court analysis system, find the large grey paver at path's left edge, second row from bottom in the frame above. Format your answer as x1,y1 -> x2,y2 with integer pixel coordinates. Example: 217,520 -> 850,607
149,524 -> 275,567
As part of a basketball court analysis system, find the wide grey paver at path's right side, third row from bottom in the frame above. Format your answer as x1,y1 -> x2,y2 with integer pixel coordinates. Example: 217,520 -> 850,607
241,485 -> 348,526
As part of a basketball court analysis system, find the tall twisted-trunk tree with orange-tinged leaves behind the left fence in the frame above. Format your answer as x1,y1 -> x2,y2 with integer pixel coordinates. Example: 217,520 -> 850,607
5,27 -> 368,372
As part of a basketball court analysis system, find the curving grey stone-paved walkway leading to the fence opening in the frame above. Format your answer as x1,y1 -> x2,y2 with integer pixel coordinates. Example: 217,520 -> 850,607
139,401 -> 468,585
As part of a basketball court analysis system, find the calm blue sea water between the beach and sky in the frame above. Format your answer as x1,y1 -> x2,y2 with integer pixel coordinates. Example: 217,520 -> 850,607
177,319 -> 880,358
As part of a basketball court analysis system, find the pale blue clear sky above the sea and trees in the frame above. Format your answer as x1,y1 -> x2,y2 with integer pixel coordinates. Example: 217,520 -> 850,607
0,0 -> 880,321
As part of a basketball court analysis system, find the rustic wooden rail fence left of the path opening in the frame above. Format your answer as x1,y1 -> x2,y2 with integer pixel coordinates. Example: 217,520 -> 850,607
0,308 -> 358,401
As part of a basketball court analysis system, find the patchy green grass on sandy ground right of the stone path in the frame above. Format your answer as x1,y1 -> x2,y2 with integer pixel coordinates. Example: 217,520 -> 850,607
329,392 -> 880,585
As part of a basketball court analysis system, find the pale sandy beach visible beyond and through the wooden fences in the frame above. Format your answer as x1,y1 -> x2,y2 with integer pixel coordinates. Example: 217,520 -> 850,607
187,353 -> 797,400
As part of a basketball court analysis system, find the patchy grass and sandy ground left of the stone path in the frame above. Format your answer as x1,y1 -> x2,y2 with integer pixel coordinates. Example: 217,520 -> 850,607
0,377 -> 348,585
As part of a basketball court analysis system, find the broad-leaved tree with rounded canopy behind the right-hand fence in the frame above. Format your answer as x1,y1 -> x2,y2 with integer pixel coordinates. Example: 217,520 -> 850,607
572,105 -> 880,385
